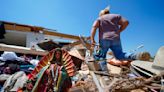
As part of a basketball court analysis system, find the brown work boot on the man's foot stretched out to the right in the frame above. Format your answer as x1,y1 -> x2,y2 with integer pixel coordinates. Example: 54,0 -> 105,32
136,52 -> 151,61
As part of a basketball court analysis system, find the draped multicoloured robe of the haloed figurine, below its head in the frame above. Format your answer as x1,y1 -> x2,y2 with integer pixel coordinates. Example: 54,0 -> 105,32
32,64 -> 68,92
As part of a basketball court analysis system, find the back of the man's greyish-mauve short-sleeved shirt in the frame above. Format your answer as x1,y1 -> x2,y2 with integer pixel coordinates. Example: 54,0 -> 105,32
98,14 -> 121,40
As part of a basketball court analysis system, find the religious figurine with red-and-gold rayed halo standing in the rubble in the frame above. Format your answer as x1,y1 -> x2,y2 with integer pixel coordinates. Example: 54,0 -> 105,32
25,49 -> 75,92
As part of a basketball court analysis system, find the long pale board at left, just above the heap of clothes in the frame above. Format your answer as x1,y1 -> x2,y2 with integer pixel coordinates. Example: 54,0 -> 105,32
0,44 -> 48,56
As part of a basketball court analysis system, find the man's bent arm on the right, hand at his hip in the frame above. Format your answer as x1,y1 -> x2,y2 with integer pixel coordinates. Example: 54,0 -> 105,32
118,17 -> 129,33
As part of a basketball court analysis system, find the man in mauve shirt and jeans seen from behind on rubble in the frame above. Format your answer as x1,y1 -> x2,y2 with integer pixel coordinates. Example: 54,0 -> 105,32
91,7 -> 150,60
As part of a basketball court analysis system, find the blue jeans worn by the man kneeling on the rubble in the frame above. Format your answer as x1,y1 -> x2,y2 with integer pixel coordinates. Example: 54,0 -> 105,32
94,39 -> 136,60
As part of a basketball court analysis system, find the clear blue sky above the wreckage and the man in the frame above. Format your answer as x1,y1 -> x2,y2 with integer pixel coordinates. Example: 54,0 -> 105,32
0,0 -> 164,56
